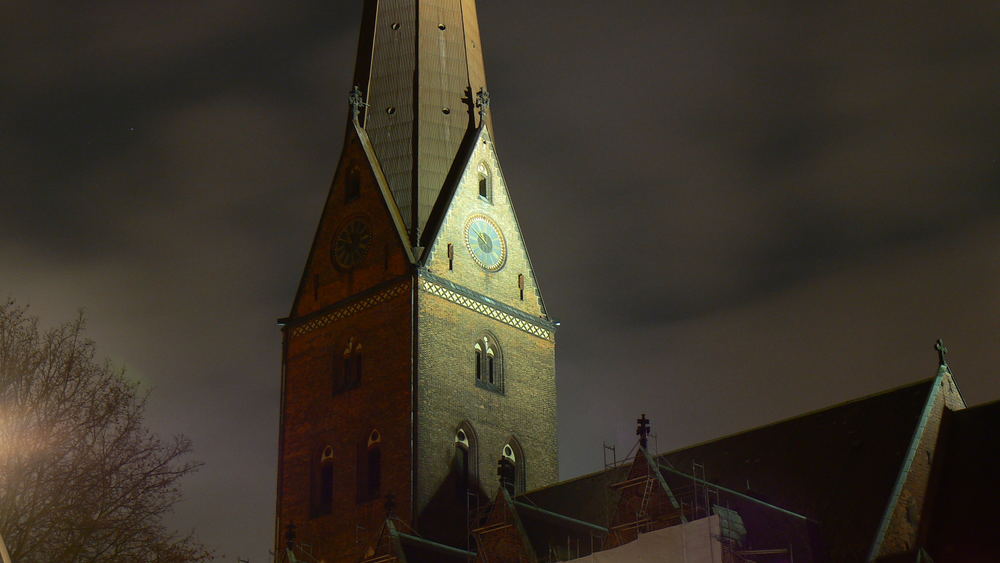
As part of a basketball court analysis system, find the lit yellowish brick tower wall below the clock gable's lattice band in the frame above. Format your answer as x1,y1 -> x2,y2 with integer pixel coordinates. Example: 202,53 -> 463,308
416,286 -> 559,540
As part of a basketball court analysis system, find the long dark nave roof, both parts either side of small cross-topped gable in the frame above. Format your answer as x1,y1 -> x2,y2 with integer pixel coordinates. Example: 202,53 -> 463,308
521,379 -> 935,561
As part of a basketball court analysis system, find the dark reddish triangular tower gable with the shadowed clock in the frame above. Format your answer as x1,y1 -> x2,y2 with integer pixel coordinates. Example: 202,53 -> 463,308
291,124 -> 413,318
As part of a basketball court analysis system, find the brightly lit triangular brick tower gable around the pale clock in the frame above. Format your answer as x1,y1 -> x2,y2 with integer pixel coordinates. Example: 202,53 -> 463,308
422,127 -> 548,319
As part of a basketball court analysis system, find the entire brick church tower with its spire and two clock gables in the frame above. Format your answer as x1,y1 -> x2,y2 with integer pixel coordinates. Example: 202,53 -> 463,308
276,0 -> 558,563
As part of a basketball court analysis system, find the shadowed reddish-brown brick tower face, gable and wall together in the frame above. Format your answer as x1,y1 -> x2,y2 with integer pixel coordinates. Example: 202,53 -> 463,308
276,131 -> 413,562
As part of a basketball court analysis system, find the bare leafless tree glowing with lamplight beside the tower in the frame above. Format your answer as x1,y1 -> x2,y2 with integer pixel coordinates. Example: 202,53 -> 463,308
0,303 -> 212,563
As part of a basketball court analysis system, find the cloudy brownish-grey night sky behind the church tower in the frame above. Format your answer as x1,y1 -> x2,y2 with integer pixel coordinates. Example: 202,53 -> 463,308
0,0 -> 1000,563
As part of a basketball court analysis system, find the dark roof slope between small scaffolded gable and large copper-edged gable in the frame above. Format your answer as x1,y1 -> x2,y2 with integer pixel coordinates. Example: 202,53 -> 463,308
660,379 -> 934,561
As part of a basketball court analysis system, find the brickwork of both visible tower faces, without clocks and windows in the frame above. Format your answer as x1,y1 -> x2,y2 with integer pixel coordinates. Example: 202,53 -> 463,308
277,122 -> 558,562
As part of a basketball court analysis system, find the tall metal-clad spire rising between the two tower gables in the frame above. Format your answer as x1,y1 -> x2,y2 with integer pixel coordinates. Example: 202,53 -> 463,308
355,0 -> 490,241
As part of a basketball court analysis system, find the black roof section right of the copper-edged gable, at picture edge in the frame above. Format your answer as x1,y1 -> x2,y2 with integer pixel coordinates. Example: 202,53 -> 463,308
925,401 -> 1000,563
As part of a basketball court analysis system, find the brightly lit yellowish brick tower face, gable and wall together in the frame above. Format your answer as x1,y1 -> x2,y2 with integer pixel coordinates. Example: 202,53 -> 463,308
416,125 -> 559,541
